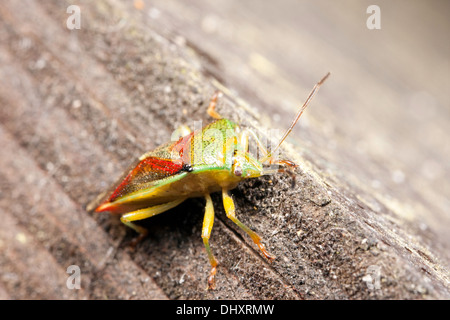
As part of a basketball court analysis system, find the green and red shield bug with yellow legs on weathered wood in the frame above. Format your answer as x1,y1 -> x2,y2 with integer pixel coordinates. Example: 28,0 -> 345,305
95,73 -> 329,289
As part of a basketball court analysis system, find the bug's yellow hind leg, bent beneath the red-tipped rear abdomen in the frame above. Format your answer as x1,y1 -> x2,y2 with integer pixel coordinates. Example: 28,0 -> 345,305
120,198 -> 186,245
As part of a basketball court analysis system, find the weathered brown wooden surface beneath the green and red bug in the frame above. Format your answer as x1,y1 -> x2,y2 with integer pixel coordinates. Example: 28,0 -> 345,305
0,0 -> 450,299
